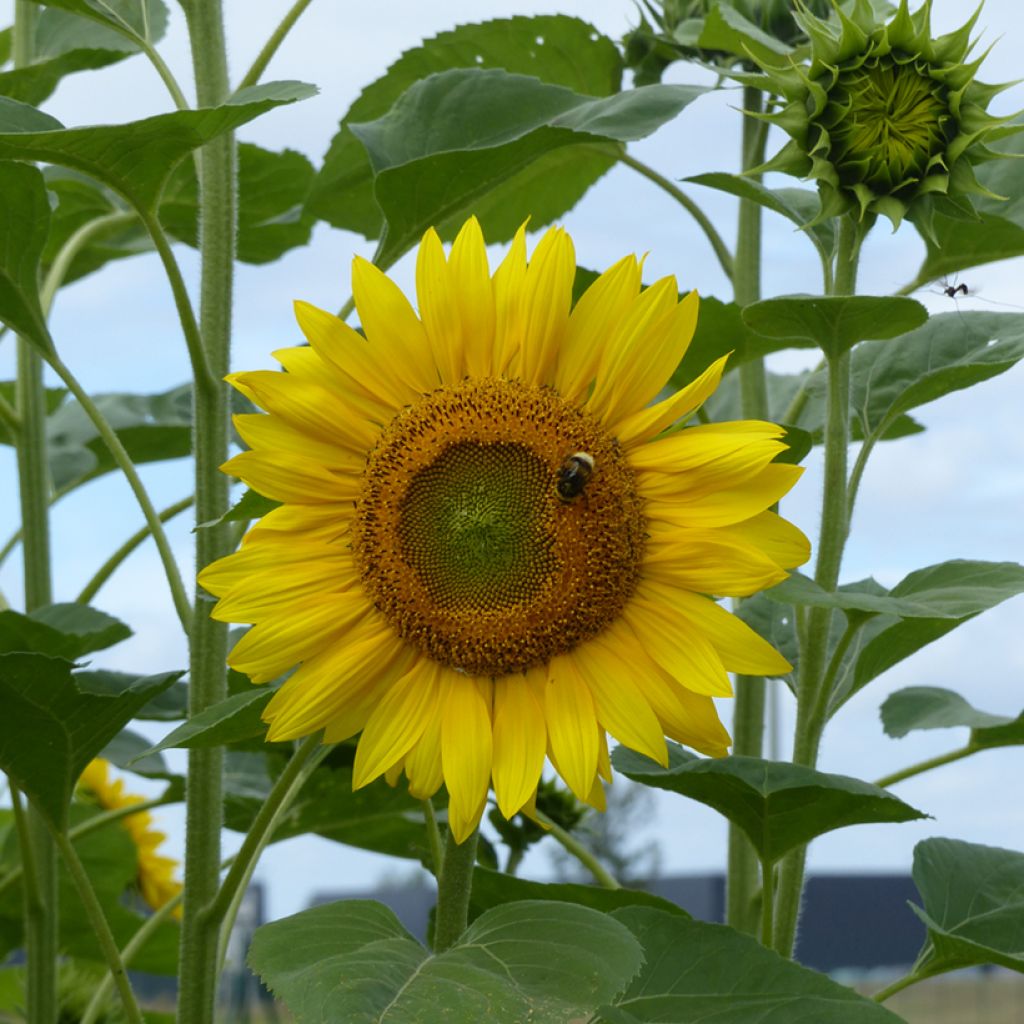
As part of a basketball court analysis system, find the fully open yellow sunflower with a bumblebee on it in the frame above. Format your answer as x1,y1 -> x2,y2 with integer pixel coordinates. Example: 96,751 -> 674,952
200,219 -> 808,842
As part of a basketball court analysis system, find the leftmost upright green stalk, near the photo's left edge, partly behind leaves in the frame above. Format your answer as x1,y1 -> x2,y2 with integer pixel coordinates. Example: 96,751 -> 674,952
12,0 -> 59,1024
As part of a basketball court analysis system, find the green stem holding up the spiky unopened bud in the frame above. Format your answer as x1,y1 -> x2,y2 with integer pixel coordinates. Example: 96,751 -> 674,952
774,216 -> 864,956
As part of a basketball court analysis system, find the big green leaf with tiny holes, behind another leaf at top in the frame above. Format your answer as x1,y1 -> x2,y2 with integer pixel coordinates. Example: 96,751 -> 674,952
309,14 -> 622,242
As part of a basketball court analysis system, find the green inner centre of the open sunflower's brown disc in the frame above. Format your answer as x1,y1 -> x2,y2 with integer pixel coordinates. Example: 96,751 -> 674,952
398,441 -> 556,609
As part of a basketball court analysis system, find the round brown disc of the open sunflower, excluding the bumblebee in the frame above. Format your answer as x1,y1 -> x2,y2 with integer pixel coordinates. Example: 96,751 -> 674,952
352,378 -> 644,676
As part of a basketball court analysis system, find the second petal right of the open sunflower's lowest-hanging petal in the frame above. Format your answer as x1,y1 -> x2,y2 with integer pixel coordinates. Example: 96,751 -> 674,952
544,654 -> 597,801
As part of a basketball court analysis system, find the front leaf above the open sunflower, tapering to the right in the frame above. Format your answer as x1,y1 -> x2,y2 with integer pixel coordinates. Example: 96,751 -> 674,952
350,68 -> 708,264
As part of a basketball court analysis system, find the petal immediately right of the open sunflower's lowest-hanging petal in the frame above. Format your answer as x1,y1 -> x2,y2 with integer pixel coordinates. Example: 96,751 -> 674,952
492,669 -> 548,818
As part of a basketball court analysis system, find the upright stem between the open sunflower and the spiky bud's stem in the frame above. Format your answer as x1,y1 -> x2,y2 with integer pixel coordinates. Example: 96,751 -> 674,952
726,87 -> 770,935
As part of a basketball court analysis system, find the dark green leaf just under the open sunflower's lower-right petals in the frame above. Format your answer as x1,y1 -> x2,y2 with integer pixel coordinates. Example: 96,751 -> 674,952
612,743 -> 926,863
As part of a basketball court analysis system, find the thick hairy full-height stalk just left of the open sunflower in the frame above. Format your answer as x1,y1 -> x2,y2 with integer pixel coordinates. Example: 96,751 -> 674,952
178,0 -> 236,1024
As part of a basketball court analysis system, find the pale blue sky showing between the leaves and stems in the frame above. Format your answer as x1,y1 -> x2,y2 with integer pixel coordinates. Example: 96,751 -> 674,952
0,0 -> 1024,915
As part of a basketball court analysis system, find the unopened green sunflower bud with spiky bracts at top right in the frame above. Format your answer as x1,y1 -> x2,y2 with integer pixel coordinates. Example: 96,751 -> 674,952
757,0 -> 1020,237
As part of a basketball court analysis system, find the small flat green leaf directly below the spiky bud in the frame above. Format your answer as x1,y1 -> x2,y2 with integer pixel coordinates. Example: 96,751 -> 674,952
743,295 -> 928,359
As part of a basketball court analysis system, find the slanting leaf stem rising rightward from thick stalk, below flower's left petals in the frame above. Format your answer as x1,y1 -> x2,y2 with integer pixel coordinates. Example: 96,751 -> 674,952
209,732 -> 331,966
